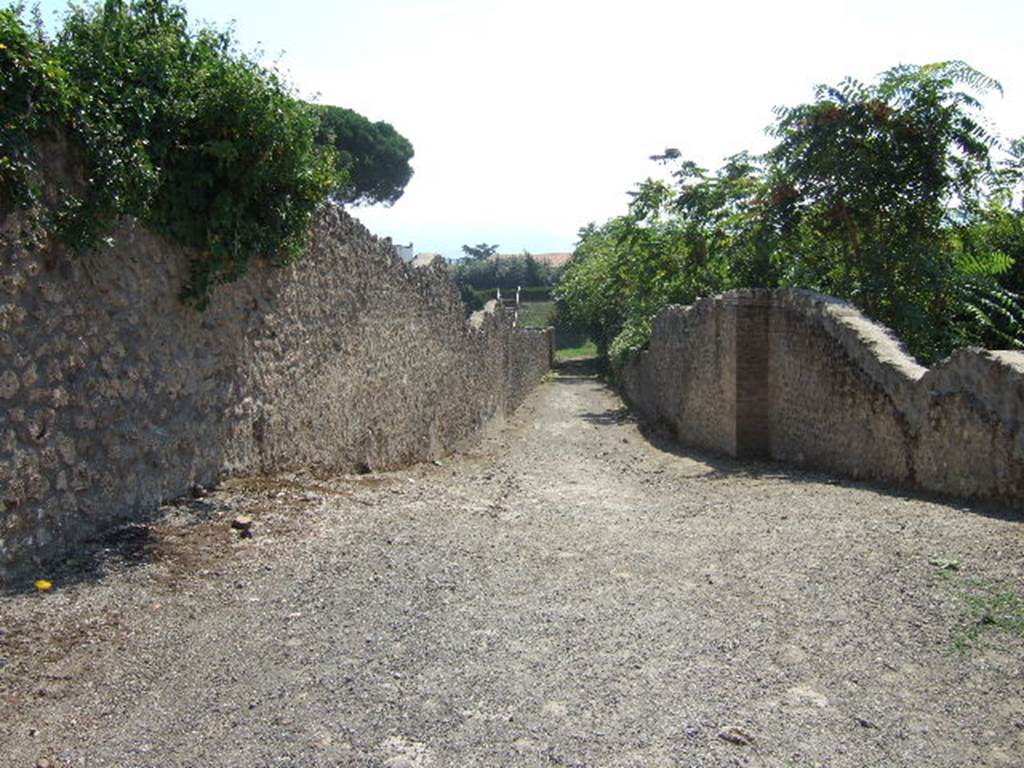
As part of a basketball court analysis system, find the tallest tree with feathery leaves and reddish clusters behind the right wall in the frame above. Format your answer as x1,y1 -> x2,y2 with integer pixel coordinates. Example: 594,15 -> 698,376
769,61 -> 999,359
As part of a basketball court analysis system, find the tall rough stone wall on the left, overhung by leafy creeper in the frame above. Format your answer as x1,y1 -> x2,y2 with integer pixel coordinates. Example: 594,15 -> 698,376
0,205 -> 551,581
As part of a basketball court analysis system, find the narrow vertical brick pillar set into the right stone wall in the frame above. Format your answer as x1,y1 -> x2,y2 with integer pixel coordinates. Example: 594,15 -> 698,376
727,291 -> 771,459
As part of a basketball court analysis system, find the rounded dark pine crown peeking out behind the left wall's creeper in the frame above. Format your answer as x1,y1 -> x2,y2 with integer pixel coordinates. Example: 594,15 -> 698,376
316,106 -> 413,205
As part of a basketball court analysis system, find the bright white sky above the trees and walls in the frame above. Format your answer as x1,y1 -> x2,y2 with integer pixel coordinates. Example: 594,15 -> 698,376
36,0 -> 1024,255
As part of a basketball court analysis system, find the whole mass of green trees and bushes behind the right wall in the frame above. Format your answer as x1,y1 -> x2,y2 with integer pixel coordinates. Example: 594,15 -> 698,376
558,61 -> 1024,362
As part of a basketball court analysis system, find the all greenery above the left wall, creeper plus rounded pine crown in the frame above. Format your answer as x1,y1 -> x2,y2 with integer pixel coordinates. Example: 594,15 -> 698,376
0,0 -> 412,308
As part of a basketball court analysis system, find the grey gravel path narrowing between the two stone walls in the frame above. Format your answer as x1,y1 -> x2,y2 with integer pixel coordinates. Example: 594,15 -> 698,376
0,365 -> 1024,768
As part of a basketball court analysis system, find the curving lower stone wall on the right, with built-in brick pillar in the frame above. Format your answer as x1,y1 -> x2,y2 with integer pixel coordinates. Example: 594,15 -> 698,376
622,290 -> 1024,506
